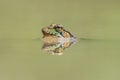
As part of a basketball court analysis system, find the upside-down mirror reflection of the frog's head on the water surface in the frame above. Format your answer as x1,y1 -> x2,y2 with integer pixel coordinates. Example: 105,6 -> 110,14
42,37 -> 76,55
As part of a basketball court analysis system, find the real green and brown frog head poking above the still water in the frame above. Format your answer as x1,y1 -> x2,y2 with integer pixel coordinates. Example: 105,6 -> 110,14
42,24 -> 74,38
